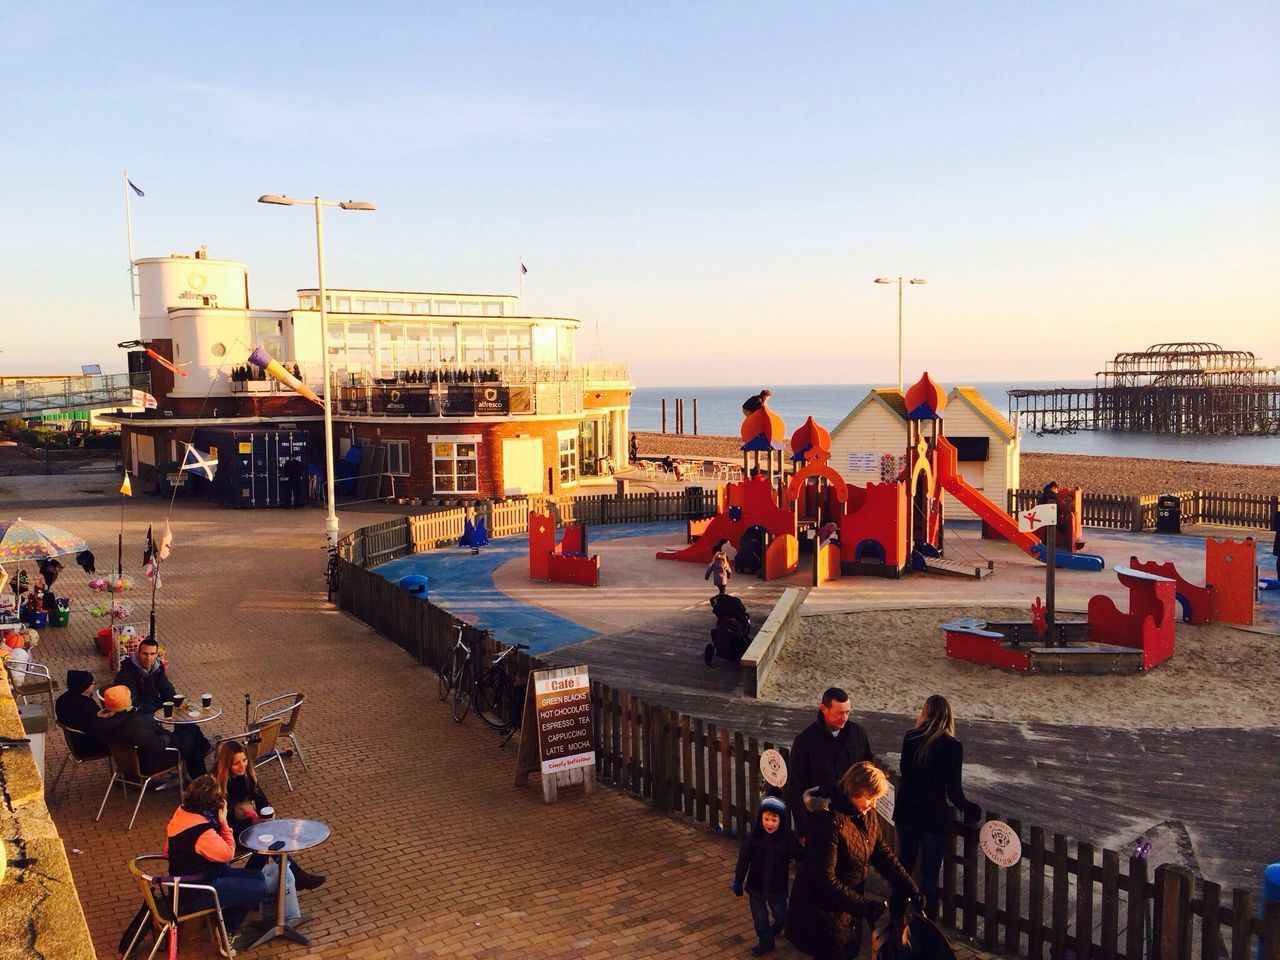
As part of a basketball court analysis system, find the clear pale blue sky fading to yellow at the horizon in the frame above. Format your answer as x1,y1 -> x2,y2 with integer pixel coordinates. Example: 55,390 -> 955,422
0,0 -> 1280,385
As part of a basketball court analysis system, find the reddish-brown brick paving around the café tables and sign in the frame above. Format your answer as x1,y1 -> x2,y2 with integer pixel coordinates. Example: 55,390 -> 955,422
17,477 -> 998,960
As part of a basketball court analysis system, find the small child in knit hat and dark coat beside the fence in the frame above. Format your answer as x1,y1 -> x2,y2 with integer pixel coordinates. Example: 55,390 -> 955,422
733,795 -> 800,956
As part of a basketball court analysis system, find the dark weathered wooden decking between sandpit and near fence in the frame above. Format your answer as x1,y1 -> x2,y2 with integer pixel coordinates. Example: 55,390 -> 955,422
545,584 -> 1280,890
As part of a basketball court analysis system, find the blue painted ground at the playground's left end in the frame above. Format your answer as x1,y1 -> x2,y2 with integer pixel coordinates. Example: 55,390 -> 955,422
374,522 -> 685,653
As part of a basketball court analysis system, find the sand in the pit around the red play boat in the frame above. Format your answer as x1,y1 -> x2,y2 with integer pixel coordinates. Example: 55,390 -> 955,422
762,607 -> 1280,728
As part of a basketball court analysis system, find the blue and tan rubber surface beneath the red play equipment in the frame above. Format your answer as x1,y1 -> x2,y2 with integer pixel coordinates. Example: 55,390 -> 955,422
376,521 -> 1280,653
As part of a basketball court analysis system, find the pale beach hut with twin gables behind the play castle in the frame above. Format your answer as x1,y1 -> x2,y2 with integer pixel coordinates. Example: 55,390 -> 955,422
831,387 -> 1019,520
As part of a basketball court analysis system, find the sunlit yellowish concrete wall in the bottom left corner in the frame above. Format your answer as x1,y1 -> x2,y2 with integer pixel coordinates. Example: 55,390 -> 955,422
0,684 -> 93,960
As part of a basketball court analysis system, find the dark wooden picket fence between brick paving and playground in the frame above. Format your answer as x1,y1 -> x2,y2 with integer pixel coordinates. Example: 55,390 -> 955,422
338,518 -> 1280,960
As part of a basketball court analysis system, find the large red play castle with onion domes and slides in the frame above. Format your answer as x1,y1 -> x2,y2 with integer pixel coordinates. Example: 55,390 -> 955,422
658,374 -> 1039,585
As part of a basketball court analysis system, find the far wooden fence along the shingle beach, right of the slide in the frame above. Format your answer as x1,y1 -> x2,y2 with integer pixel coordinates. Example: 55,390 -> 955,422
1009,490 -> 1280,534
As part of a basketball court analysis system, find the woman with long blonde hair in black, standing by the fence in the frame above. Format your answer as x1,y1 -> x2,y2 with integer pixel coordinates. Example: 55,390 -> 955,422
893,694 -> 982,919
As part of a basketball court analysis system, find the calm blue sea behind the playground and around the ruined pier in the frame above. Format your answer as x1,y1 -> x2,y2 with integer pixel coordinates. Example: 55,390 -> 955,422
631,380 -> 1280,465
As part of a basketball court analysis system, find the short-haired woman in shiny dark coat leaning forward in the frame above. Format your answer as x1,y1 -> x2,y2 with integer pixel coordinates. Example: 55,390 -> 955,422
787,762 -> 920,960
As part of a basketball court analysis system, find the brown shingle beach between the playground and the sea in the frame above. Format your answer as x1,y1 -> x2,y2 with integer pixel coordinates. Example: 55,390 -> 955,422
636,433 -> 1280,497
